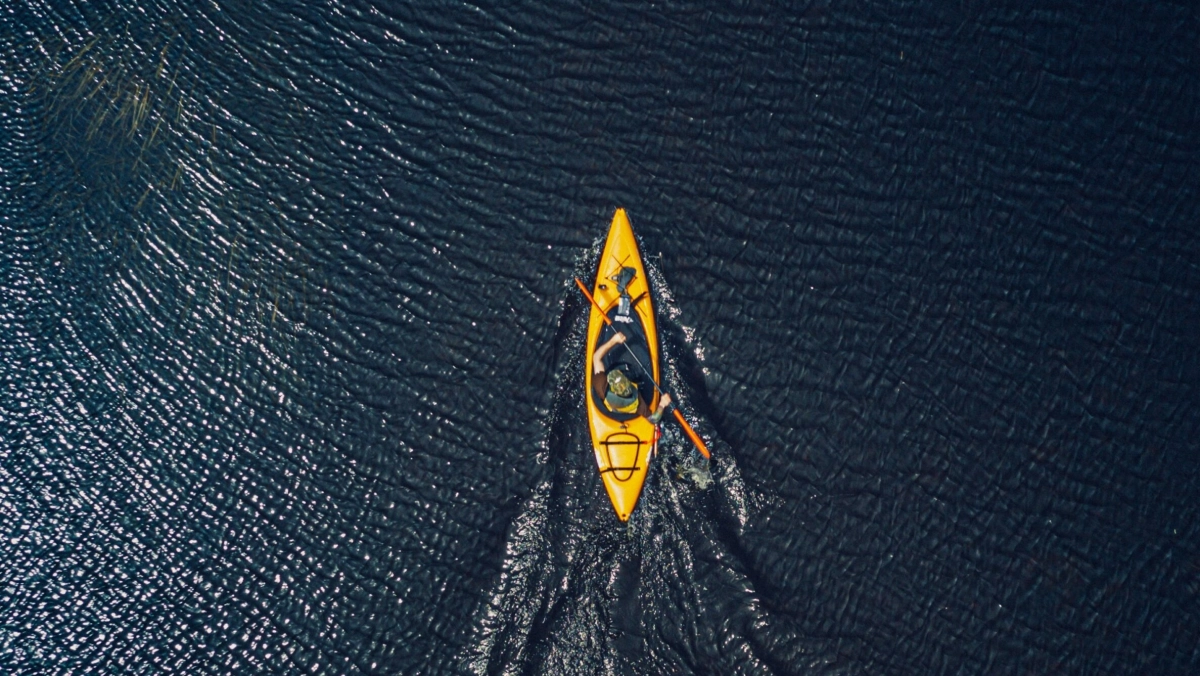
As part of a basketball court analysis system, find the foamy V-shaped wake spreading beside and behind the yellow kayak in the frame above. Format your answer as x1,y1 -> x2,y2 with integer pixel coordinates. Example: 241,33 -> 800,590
462,246 -> 787,675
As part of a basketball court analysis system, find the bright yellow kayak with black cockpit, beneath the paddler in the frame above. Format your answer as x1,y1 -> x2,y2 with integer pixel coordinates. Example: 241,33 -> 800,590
583,209 -> 659,521
